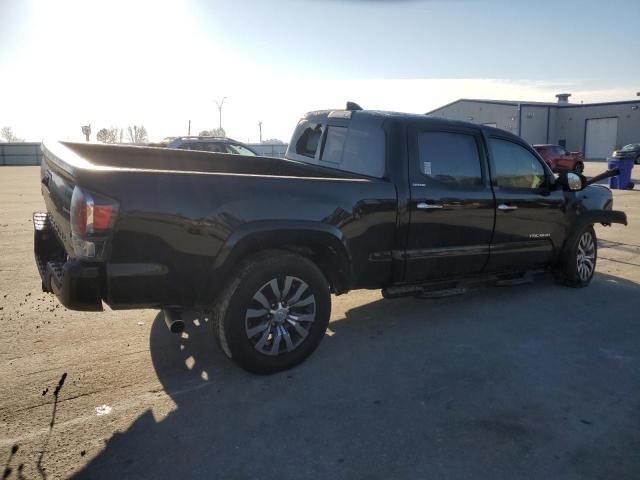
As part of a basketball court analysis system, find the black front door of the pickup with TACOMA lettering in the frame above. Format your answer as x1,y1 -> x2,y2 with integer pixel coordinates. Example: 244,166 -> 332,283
487,136 -> 565,271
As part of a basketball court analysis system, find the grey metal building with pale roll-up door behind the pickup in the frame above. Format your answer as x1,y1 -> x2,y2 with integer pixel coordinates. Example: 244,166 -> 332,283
427,93 -> 640,160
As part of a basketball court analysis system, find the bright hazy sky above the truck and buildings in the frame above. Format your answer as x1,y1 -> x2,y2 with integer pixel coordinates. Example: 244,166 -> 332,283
0,0 -> 640,142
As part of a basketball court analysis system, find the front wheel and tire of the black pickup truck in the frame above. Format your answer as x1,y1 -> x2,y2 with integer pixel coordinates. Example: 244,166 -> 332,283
556,225 -> 598,288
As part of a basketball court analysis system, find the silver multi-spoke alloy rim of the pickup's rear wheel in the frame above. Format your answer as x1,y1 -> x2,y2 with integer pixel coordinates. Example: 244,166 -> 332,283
244,275 -> 316,356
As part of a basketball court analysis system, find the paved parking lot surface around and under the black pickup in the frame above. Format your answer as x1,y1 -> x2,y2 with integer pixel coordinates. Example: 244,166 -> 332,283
0,163 -> 640,479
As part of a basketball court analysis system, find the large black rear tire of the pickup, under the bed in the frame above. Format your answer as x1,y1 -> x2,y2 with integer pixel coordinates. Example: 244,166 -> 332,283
212,250 -> 331,374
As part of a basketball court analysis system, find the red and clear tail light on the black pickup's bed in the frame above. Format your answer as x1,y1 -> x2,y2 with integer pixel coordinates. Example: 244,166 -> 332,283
70,187 -> 118,257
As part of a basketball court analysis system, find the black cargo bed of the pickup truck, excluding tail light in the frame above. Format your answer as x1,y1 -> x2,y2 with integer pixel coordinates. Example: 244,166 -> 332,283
40,142 -> 397,309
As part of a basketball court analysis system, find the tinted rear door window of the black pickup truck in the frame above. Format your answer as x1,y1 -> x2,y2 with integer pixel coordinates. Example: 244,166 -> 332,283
418,132 -> 483,187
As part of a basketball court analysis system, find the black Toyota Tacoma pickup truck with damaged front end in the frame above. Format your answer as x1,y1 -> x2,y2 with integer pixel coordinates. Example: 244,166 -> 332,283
34,107 -> 627,373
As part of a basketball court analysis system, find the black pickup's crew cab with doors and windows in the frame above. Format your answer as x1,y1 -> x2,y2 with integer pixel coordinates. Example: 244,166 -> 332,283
286,110 -> 604,284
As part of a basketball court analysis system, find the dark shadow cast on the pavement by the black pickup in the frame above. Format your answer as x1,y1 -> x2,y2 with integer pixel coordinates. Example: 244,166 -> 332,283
77,274 -> 640,479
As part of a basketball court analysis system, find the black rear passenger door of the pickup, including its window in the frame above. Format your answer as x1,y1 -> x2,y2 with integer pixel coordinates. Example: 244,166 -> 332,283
405,127 -> 495,282
